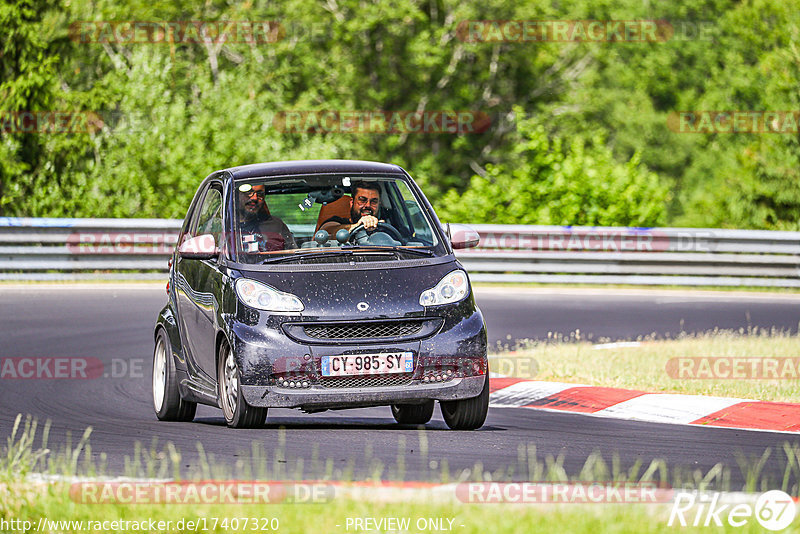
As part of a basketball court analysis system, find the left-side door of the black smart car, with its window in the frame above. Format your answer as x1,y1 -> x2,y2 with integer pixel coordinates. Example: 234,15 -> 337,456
176,182 -> 222,379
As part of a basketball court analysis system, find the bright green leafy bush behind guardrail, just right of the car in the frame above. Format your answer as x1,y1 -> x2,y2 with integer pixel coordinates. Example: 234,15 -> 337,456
436,109 -> 669,226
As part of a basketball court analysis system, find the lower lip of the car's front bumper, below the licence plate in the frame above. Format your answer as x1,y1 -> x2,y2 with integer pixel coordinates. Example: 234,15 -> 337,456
241,375 -> 486,409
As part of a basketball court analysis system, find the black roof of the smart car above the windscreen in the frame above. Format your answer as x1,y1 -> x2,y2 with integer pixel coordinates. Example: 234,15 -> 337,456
225,159 -> 403,179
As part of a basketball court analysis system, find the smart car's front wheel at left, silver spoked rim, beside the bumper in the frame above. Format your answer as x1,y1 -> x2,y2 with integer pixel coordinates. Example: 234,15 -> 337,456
217,343 -> 267,428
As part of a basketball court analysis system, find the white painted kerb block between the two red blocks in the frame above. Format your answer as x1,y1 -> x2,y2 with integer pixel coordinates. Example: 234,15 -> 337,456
595,393 -> 744,424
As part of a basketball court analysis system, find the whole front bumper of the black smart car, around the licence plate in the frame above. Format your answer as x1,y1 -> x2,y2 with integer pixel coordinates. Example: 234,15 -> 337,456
231,302 -> 489,409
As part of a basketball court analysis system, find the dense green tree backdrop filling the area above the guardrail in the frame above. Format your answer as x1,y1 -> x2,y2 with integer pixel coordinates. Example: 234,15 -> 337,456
0,0 -> 800,229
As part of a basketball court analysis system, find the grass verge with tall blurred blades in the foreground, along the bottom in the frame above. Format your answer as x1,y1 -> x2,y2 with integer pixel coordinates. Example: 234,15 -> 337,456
0,415 -> 800,534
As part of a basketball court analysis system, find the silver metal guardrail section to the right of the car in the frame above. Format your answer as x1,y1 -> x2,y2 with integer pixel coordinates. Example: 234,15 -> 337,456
459,225 -> 800,287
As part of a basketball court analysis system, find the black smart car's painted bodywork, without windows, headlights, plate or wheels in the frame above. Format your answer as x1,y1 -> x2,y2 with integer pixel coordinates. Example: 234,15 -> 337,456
156,160 -> 488,420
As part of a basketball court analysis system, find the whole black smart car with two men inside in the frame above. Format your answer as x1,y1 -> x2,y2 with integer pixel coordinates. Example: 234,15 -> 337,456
153,160 -> 489,429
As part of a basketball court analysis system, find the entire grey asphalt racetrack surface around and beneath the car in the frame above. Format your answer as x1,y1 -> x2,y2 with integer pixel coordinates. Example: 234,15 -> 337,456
0,284 -> 800,487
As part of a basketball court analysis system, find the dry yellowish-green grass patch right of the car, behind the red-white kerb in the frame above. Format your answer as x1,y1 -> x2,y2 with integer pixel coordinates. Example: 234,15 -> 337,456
489,328 -> 800,402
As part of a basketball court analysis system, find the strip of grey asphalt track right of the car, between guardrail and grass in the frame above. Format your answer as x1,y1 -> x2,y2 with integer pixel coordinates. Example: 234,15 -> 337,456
476,287 -> 800,345
